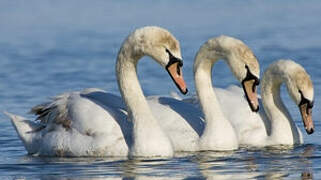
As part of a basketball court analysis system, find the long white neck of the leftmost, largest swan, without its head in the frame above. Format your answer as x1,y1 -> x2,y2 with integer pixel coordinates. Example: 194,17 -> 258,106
116,34 -> 173,157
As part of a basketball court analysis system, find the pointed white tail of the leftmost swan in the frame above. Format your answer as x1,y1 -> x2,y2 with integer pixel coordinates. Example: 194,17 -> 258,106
4,112 -> 45,154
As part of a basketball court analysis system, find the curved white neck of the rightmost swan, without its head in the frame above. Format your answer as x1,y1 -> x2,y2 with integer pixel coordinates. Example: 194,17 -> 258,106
261,67 -> 299,144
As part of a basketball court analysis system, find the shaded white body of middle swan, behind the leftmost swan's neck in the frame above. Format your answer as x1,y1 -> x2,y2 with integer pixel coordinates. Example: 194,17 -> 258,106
147,96 -> 205,151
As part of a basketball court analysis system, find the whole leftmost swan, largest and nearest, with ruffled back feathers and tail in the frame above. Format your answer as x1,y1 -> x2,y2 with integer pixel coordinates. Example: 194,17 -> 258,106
6,26 -> 187,157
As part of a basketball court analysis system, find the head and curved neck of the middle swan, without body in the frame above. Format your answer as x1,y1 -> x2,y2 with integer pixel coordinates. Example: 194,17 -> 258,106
194,36 -> 259,150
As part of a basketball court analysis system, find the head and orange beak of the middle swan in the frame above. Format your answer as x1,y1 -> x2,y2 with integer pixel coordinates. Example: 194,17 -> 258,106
208,36 -> 260,112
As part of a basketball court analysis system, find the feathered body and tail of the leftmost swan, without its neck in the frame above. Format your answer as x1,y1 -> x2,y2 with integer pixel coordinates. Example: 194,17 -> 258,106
6,90 -> 132,156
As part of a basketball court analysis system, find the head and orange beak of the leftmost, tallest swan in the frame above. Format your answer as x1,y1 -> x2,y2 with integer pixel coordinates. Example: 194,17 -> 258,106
128,26 -> 188,94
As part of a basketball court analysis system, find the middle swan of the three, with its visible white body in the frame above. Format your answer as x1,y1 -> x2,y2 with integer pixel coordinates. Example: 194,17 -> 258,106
159,36 -> 259,151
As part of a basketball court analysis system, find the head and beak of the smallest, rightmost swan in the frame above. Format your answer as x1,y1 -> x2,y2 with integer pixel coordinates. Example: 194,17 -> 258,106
277,60 -> 314,134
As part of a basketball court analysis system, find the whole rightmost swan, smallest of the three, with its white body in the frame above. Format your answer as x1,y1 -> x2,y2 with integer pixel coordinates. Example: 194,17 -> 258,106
216,60 -> 314,147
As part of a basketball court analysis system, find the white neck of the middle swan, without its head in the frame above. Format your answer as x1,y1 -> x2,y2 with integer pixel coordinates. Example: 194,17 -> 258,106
194,43 -> 237,150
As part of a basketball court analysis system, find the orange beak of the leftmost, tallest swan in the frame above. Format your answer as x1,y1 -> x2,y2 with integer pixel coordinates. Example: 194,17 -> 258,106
166,62 -> 188,94
